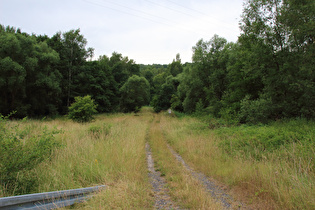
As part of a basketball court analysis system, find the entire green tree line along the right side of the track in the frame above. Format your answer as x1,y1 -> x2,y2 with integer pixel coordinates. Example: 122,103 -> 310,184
152,0 -> 315,123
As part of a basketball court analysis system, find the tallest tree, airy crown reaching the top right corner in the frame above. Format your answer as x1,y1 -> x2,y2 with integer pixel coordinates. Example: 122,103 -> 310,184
239,0 -> 315,119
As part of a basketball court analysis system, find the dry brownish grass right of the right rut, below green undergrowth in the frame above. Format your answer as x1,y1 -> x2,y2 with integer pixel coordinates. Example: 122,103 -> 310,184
161,116 -> 315,209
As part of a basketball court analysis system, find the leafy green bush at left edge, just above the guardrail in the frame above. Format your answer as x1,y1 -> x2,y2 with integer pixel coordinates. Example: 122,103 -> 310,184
0,114 -> 61,195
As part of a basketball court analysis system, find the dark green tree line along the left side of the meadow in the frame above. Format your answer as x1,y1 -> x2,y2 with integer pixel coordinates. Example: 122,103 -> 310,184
0,26 -> 149,117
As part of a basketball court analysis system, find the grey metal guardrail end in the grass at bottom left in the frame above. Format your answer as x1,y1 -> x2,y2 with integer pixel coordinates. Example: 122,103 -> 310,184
0,185 -> 105,210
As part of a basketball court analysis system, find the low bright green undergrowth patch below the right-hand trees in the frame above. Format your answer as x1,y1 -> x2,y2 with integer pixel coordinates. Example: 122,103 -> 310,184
215,119 -> 315,165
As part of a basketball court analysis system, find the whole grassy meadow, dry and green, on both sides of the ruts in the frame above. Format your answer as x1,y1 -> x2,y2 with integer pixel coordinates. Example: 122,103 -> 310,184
0,108 -> 315,209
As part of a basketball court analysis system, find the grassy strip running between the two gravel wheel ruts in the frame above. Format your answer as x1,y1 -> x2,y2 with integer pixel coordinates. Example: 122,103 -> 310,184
148,115 -> 222,209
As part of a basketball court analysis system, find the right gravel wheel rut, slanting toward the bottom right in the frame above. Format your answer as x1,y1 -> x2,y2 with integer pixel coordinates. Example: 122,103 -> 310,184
167,145 -> 246,209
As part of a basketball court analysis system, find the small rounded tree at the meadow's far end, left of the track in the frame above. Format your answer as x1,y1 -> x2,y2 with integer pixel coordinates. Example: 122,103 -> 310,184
120,75 -> 150,112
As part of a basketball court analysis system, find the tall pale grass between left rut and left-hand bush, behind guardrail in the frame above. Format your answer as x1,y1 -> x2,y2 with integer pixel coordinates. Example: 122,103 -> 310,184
1,112 -> 153,209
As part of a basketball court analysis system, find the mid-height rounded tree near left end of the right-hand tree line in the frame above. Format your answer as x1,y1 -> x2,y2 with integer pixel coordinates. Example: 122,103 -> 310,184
180,35 -> 228,116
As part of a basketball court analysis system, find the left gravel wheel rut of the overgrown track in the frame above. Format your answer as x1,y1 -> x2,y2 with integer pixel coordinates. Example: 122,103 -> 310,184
145,143 -> 179,209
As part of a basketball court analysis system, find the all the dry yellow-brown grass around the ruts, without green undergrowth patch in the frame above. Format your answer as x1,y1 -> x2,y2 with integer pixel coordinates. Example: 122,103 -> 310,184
3,109 -> 315,209
